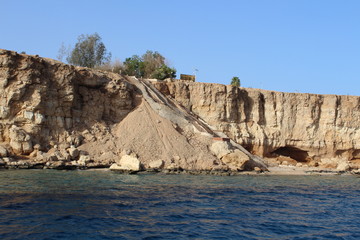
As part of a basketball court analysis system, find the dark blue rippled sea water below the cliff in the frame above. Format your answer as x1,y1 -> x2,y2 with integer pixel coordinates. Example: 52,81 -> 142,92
0,170 -> 360,239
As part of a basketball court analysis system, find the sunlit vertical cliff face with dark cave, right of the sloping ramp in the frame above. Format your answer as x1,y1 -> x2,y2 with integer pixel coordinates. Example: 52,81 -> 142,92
154,82 -> 360,167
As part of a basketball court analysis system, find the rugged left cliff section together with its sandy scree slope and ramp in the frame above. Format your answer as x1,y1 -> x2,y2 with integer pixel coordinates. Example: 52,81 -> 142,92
0,50 -> 265,171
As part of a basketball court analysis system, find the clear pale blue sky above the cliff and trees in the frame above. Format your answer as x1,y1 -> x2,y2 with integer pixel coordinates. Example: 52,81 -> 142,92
0,0 -> 360,95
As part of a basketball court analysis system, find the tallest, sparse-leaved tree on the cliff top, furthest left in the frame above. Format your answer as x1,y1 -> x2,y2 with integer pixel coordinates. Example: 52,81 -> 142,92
67,33 -> 111,68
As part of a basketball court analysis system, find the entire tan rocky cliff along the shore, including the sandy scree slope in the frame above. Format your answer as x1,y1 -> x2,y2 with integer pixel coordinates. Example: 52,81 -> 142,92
0,50 -> 360,171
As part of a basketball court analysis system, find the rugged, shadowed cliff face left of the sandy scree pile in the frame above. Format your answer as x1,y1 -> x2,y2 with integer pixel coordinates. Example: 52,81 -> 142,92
0,50 -> 134,155
